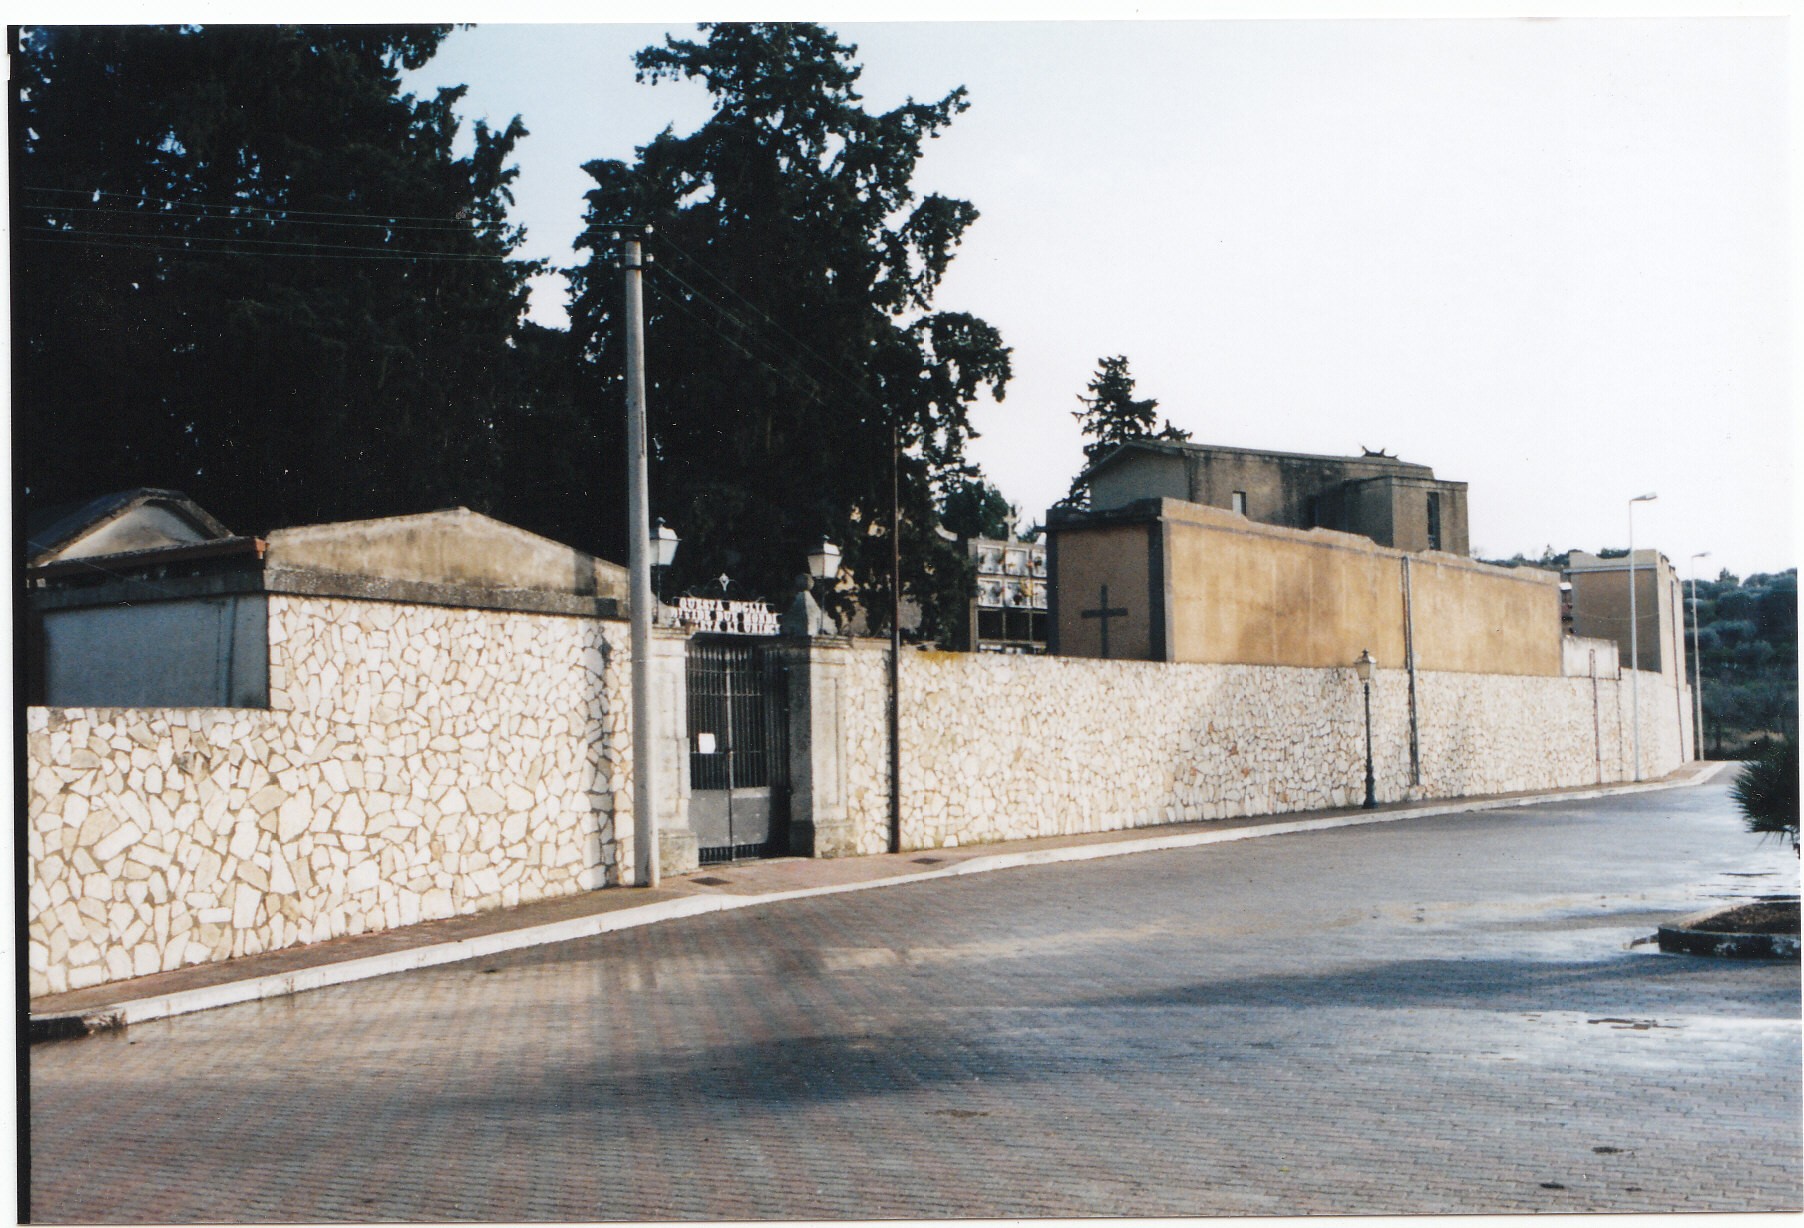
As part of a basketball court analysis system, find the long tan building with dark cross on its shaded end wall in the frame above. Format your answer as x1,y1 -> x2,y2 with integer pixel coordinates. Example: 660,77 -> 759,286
1048,498 -> 1562,676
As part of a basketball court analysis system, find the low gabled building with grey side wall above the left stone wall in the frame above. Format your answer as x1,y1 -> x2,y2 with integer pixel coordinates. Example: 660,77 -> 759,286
25,489 -> 626,707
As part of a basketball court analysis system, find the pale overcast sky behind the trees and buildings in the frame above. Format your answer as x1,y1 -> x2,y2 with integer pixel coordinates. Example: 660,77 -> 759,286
411,18 -> 1797,575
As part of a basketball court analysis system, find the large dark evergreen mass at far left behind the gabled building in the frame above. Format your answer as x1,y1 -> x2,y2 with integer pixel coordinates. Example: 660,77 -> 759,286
11,25 -> 556,532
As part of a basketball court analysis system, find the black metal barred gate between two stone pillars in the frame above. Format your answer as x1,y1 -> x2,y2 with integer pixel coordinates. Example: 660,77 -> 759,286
689,637 -> 788,866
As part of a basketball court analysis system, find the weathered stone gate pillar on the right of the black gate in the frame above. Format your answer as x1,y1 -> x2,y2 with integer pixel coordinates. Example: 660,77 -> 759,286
785,637 -> 859,857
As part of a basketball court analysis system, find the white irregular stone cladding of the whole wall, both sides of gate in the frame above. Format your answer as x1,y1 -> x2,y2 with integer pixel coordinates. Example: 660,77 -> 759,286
25,609 -> 1690,997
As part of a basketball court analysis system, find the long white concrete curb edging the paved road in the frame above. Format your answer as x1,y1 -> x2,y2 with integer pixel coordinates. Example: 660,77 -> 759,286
29,763 -> 1734,1044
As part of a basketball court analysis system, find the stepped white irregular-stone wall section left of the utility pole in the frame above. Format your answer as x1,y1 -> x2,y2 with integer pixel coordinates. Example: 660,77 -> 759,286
27,595 -> 631,995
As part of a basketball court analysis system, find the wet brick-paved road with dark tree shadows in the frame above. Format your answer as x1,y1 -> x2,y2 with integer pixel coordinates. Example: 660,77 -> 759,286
31,784 -> 1804,1221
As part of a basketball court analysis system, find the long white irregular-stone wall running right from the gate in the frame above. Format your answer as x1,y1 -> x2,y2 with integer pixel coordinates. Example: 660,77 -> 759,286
844,642 -> 1690,853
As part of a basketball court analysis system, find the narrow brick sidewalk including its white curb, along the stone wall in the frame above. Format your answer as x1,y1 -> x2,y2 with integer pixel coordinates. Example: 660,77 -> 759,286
31,761 -> 1734,1042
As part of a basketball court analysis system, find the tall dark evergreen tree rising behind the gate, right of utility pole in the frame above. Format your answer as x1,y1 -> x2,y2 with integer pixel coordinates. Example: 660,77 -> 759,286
572,23 -> 1010,635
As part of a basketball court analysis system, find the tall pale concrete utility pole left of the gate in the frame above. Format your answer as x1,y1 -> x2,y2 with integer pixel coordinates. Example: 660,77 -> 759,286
621,225 -> 658,887
